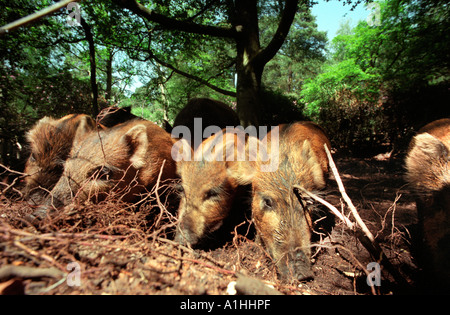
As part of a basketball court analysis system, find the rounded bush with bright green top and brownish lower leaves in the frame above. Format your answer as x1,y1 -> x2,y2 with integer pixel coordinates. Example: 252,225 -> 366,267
301,59 -> 383,151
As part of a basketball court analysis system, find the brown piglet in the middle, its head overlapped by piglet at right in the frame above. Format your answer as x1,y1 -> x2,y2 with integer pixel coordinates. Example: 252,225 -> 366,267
176,128 -> 255,247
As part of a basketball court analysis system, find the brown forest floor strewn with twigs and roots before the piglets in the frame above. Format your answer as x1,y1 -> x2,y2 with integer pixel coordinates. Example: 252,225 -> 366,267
0,158 -> 420,295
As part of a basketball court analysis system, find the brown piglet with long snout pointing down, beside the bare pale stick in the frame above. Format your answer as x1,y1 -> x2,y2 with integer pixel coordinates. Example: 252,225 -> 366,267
241,122 -> 330,280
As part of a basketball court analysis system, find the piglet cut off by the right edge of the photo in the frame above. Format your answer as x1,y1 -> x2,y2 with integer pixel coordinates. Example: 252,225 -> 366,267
405,118 -> 450,290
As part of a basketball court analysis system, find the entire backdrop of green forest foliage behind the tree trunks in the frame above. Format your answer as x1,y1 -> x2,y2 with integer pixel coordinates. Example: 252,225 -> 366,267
0,0 -> 450,162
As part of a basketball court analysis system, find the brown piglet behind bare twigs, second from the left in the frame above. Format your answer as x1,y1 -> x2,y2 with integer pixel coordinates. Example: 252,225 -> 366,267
30,120 -> 176,221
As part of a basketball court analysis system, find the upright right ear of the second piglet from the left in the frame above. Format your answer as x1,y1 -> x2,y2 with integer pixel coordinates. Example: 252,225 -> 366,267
124,125 -> 148,169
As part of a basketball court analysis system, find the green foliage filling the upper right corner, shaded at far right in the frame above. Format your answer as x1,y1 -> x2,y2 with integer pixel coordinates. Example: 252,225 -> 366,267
300,0 -> 450,153
